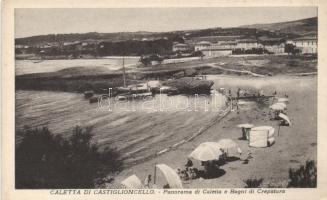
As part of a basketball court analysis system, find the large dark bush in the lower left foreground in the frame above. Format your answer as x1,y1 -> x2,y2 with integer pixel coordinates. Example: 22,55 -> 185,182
16,126 -> 122,189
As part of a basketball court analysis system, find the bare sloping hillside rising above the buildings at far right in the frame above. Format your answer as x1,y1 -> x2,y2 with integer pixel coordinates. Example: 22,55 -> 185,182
241,17 -> 318,35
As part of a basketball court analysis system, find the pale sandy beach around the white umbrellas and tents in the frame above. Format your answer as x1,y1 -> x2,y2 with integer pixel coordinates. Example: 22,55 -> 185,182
113,76 -> 317,188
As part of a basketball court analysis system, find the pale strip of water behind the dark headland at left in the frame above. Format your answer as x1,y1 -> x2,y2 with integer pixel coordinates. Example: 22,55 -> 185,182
15,57 -> 139,75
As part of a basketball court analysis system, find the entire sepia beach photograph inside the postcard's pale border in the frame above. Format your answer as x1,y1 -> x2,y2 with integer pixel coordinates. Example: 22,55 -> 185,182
13,6 -> 319,191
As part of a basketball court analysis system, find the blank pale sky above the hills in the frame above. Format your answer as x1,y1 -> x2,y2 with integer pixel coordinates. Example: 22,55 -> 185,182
15,7 -> 318,38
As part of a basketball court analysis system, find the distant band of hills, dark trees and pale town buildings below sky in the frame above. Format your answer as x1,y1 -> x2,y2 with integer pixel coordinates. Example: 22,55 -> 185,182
15,18 -> 317,64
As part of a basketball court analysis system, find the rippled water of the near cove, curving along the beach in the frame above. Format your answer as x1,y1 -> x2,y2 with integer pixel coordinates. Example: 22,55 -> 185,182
15,90 -> 225,165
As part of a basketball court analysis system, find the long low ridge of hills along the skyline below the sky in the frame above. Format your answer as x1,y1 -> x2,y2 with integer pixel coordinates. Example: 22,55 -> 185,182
15,17 -> 318,46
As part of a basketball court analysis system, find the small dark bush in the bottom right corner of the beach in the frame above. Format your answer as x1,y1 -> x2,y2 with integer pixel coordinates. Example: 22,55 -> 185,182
287,160 -> 317,188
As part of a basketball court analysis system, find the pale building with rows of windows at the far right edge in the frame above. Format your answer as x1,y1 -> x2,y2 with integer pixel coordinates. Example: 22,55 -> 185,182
287,36 -> 318,54
